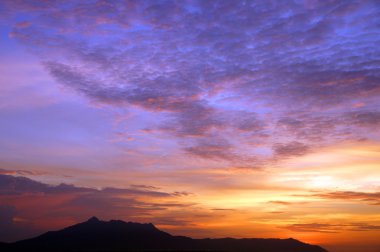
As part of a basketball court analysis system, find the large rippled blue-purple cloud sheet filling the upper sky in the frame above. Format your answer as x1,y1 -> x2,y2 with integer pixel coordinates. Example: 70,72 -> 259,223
3,1 -> 380,162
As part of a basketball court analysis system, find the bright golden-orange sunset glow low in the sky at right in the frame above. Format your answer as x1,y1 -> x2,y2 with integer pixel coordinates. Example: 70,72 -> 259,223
3,143 -> 380,252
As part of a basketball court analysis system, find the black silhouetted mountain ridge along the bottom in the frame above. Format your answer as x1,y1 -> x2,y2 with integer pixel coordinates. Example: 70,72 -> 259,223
0,217 -> 327,252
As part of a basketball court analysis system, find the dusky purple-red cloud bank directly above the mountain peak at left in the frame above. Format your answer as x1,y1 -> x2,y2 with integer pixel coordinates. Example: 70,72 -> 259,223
0,175 -> 196,241
